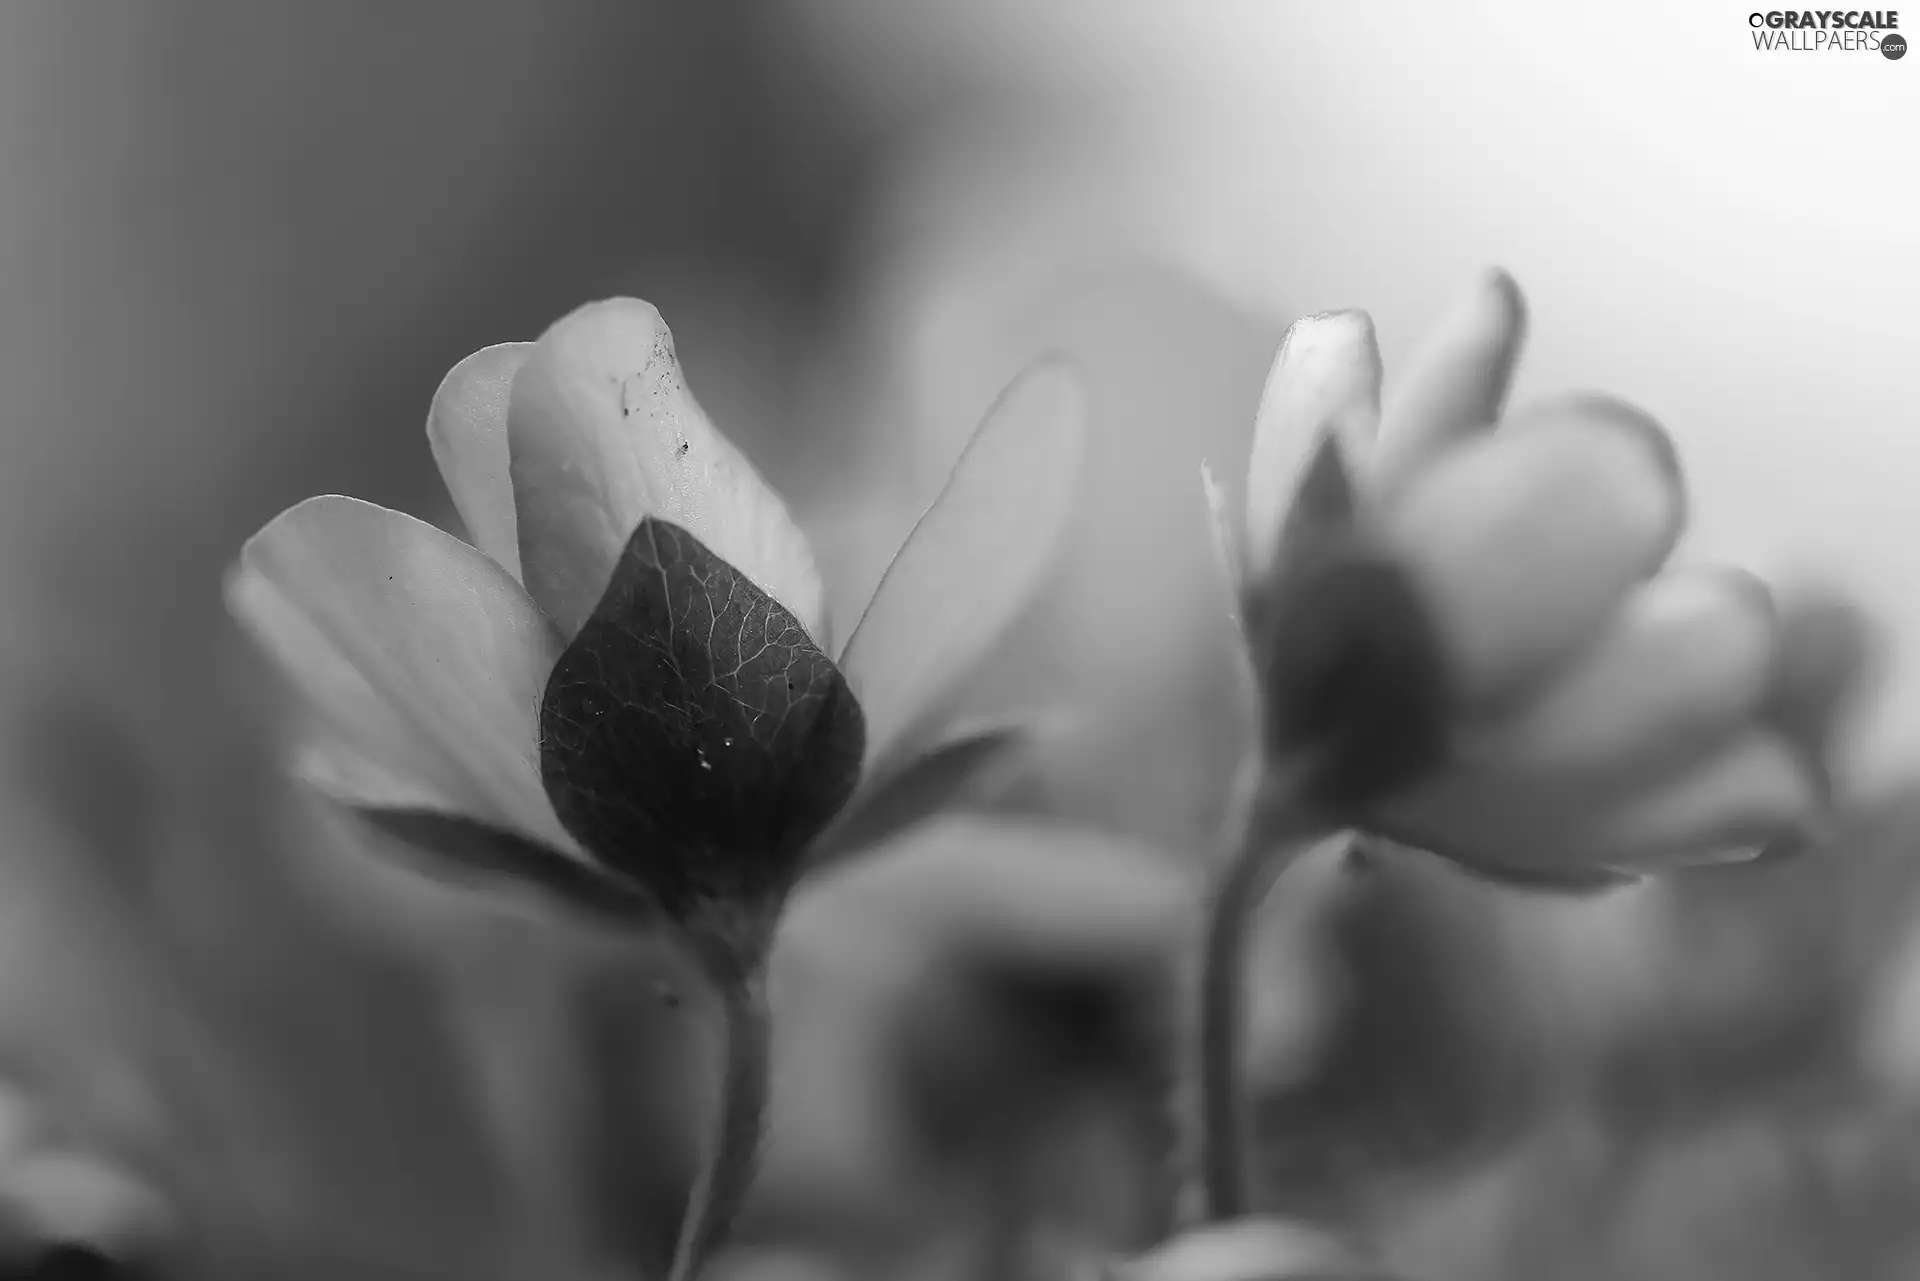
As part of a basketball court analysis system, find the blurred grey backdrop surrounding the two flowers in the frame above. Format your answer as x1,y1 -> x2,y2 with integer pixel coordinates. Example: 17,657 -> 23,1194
0,0 -> 1920,1281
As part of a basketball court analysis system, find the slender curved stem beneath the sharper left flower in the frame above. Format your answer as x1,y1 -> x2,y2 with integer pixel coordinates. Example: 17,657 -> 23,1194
672,968 -> 772,1281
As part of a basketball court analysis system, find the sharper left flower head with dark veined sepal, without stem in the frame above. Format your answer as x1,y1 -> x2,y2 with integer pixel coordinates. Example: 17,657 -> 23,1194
230,302 -> 1083,960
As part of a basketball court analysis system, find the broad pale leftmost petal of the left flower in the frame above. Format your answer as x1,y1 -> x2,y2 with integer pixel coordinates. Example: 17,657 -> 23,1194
227,497 -> 574,851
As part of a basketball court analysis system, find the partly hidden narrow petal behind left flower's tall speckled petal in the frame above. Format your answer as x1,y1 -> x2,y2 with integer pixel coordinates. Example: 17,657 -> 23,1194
426,342 -> 534,578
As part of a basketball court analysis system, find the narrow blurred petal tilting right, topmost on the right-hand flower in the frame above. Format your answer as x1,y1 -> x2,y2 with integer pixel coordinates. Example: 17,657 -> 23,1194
1375,269 -> 1526,492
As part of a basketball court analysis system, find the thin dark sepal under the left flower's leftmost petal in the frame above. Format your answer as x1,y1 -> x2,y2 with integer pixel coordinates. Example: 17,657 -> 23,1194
351,805 -> 660,928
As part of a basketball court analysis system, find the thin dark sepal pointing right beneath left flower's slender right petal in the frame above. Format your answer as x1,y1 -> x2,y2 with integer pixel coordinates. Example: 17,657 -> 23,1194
808,722 -> 1035,870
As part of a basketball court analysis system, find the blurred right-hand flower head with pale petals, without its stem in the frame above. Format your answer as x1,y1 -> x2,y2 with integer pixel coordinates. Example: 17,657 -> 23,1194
1208,273 -> 1862,887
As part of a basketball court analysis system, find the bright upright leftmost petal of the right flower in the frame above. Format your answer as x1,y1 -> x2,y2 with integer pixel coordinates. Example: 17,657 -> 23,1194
1246,311 -> 1380,578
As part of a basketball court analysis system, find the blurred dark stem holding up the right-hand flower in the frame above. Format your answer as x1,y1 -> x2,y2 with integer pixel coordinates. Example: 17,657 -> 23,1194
1198,768 -> 1325,1223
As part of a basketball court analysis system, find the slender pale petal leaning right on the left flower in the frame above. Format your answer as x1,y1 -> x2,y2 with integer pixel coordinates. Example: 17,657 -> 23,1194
841,361 -> 1087,761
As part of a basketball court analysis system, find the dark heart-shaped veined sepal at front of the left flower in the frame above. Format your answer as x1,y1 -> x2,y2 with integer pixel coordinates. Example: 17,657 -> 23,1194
540,517 -> 866,922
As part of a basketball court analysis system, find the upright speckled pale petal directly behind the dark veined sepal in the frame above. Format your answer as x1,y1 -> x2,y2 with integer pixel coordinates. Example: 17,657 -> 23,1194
507,298 -> 828,649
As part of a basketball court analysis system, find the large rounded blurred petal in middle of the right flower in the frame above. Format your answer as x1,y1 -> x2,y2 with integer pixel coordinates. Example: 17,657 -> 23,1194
1382,398 -> 1686,701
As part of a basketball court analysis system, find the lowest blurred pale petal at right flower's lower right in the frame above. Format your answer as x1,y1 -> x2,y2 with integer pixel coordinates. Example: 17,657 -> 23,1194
1594,730 -> 1820,870
